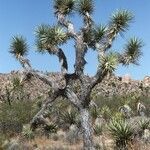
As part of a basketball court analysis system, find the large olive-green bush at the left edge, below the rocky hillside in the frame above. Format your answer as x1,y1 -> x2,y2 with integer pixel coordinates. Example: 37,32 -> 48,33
0,100 -> 37,134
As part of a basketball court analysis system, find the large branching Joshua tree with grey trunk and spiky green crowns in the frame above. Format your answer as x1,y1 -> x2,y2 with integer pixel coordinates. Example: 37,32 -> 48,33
10,0 -> 143,150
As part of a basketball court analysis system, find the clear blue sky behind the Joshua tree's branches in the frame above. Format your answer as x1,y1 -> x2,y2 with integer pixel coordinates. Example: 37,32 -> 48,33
0,0 -> 150,79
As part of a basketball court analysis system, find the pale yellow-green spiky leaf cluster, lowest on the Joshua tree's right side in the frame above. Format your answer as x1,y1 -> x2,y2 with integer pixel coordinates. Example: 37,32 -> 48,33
99,52 -> 118,73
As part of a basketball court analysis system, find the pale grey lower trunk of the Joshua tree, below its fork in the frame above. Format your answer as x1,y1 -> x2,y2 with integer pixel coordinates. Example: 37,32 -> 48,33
80,108 -> 95,150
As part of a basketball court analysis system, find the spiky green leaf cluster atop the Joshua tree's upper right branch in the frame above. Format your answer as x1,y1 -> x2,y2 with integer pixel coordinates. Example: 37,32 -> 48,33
110,10 -> 133,32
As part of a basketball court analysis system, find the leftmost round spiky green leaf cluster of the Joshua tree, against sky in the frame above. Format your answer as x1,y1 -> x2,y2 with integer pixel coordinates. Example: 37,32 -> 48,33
9,36 -> 28,57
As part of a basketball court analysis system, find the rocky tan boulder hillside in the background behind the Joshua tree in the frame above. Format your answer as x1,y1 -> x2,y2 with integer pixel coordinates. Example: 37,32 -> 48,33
0,71 -> 150,99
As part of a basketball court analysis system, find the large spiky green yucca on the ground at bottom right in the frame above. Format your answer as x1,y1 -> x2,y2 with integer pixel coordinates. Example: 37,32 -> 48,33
108,120 -> 133,150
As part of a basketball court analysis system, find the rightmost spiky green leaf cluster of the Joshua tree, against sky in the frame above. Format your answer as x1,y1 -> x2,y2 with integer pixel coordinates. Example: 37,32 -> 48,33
122,38 -> 143,65
